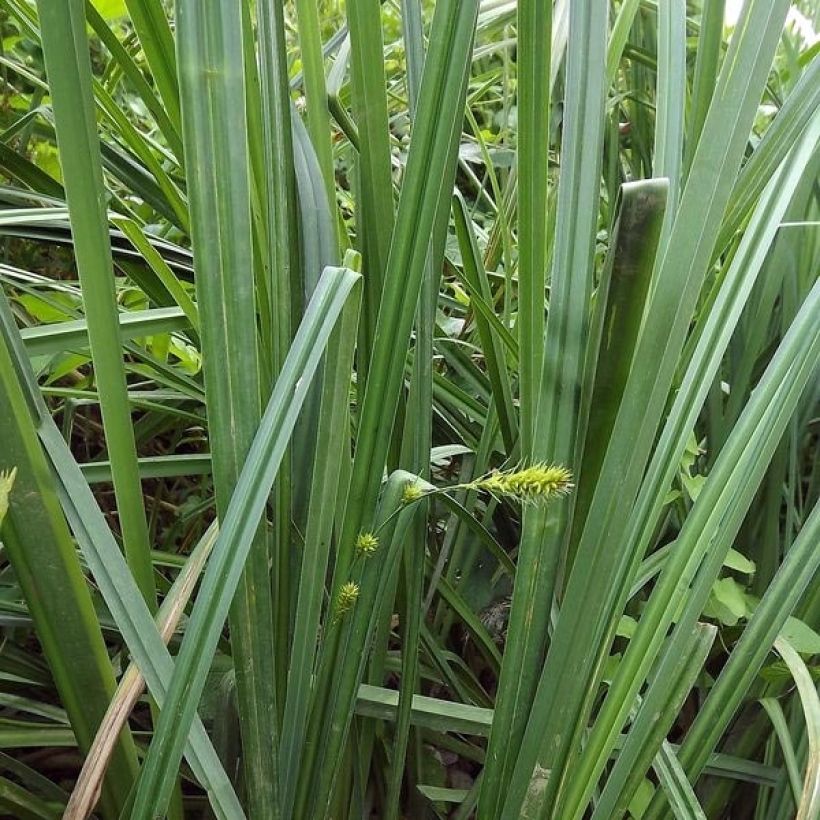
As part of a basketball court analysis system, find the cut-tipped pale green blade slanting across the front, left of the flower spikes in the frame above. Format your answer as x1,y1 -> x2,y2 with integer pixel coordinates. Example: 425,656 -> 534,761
132,268 -> 358,820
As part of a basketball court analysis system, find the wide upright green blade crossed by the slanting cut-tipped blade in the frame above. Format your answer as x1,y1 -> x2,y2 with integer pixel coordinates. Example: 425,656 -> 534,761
175,0 -> 289,817
